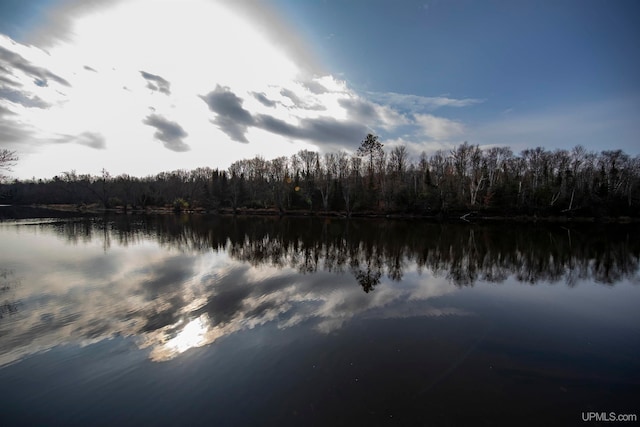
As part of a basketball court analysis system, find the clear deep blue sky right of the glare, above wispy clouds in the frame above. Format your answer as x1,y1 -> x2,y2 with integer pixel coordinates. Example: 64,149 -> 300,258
279,0 -> 640,117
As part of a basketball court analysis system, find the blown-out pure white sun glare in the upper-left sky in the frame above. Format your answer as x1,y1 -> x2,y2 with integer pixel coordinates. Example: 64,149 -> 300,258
13,0 -> 306,175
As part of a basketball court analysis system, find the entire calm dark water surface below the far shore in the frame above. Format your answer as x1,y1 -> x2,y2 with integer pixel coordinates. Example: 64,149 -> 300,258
0,207 -> 640,426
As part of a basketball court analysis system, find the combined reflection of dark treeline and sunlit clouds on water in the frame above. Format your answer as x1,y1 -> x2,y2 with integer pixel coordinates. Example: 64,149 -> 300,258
0,216 -> 640,366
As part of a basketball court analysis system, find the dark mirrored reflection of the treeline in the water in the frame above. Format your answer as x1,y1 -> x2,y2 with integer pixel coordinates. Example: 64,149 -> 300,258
50,215 -> 640,292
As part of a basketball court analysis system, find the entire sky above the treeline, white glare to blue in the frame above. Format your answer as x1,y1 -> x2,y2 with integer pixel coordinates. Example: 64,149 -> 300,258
0,0 -> 640,179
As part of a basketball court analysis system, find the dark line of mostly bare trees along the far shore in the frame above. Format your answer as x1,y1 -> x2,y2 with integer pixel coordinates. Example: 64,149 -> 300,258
0,134 -> 640,217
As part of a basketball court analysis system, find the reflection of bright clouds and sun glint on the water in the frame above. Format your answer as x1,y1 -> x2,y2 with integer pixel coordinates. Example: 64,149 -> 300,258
0,225 -> 465,366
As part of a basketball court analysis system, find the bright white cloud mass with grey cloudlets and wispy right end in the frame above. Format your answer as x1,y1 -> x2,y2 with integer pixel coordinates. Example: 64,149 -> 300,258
0,0 -> 480,177
